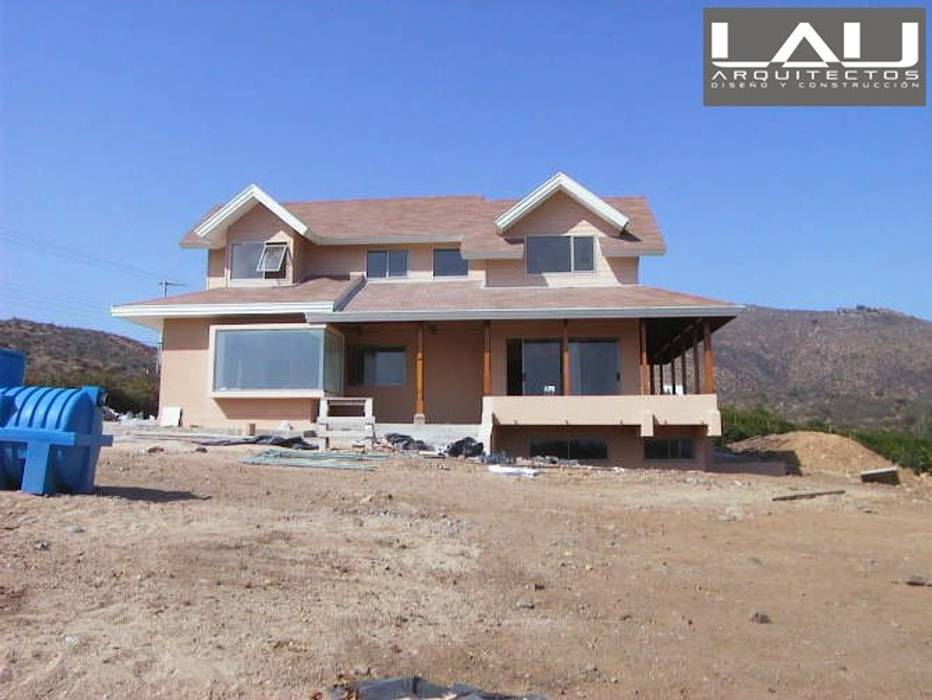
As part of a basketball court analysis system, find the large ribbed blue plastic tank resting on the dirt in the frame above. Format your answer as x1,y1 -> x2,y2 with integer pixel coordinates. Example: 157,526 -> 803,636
0,386 -> 113,494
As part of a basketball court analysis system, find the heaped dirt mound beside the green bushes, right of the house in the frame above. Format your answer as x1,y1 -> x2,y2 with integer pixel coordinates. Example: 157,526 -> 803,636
729,430 -> 893,474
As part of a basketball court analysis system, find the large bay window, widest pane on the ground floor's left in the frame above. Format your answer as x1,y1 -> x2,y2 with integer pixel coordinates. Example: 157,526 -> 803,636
214,328 -> 326,391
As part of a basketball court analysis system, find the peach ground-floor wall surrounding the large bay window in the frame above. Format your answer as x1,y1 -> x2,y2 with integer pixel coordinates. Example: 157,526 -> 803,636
159,317 -> 317,430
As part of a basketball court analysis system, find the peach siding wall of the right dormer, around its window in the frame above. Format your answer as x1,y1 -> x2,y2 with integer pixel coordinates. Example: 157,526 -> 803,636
486,192 -> 638,287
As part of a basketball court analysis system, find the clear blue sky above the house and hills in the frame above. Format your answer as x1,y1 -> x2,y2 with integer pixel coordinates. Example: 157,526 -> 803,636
0,0 -> 932,340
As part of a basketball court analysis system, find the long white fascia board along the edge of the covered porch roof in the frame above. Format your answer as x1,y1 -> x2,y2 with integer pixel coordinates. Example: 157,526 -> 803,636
304,305 -> 744,323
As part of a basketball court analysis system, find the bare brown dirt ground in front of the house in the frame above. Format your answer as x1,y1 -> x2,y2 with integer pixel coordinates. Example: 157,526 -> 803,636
0,434 -> 932,698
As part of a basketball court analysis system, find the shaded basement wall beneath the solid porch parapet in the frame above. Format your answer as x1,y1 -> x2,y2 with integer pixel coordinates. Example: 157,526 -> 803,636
493,425 -> 712,469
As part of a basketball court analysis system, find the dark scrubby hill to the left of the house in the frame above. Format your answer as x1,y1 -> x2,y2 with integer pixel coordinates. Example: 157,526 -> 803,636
0,318 -> 158,414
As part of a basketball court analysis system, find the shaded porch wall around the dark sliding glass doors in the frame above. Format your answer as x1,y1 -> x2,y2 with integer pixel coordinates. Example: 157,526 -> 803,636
492,319 -> 641,396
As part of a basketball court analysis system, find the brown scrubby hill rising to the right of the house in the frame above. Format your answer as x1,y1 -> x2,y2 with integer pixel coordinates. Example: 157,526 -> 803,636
713,307 -> 932,428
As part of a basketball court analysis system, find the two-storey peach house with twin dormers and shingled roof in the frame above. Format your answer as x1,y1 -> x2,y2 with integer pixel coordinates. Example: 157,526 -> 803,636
112,173 -> 741,468
